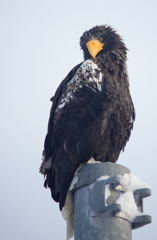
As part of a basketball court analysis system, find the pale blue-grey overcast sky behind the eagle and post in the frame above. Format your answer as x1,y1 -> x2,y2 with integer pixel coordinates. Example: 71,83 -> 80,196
0,0 -> 157,240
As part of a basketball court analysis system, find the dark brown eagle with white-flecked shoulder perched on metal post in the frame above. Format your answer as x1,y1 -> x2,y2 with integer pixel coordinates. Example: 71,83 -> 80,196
40,25 -> 135,210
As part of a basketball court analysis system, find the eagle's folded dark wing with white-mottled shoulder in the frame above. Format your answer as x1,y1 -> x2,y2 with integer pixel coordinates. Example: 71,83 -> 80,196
42,61 -> 109,209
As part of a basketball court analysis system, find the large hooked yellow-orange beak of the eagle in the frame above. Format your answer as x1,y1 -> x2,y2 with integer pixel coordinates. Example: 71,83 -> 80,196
87,40 -> 104,59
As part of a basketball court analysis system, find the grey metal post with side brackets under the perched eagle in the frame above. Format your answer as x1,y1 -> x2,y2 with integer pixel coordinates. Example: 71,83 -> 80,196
74,163 -> 151,240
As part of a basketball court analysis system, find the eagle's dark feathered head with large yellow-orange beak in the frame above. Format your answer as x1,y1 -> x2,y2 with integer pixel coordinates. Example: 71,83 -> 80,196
80,25 -> 127,60
